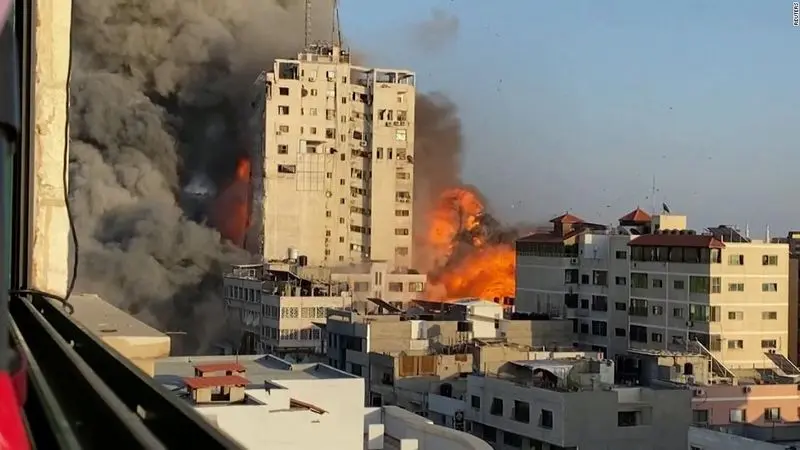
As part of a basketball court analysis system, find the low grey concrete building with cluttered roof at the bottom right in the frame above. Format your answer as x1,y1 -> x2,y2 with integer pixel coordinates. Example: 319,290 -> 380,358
464,357 -> 691,450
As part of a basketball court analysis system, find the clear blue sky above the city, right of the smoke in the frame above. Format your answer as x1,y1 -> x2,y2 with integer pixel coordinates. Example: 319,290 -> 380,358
340,0 -> 800,235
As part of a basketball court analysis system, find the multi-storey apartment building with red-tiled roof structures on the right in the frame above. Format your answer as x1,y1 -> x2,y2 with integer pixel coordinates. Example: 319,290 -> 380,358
516,209 -> 794,370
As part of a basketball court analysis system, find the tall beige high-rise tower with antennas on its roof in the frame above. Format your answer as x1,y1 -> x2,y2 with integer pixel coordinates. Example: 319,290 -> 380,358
246,45 -> 415,269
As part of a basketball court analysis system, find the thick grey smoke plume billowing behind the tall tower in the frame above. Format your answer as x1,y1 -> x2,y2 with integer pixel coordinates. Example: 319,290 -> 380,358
70,0 -> 468,351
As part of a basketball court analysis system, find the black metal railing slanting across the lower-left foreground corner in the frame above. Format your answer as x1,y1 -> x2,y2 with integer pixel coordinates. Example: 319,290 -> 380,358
9,296 -> 241,449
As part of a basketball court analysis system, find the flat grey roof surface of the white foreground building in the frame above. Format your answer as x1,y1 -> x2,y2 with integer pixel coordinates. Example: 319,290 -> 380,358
154,355 -> 357,387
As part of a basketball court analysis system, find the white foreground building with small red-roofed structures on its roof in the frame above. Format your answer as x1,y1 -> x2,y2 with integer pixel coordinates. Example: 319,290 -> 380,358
150,355 -> 491,450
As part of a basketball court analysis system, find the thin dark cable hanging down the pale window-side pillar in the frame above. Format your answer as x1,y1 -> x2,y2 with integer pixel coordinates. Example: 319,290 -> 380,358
9,0 -> 80,315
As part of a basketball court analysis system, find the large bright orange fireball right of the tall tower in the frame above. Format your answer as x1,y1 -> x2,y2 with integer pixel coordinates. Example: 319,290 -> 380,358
425,188 -> 515,300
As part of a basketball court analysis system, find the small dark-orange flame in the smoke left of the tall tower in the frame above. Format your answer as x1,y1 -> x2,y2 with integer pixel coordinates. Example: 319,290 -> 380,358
213,158 -> 250,247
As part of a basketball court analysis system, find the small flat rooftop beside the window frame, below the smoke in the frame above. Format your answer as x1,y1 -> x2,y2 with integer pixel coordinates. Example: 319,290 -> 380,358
69,294 -> 167,338
